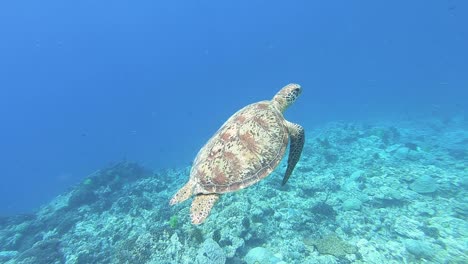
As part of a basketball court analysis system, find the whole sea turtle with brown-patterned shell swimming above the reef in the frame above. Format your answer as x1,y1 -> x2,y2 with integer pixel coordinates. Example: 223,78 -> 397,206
170,84 -> 304,224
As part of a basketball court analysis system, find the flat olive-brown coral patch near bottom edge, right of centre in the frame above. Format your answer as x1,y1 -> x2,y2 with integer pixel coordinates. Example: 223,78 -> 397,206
305,234 -> 357,257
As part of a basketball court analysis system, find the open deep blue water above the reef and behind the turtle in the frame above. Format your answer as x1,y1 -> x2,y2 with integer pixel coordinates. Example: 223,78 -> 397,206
0,0 -> 468,215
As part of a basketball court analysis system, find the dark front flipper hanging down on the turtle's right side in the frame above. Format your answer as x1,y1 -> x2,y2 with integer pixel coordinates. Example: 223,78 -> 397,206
281,121 -> 305,185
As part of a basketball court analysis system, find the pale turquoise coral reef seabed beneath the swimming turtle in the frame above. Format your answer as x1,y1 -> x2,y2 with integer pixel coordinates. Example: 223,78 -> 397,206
0,115 -> 468,264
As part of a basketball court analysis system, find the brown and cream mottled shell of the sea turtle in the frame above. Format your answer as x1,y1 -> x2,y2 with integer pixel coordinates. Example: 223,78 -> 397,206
190,101 -> 289,194
